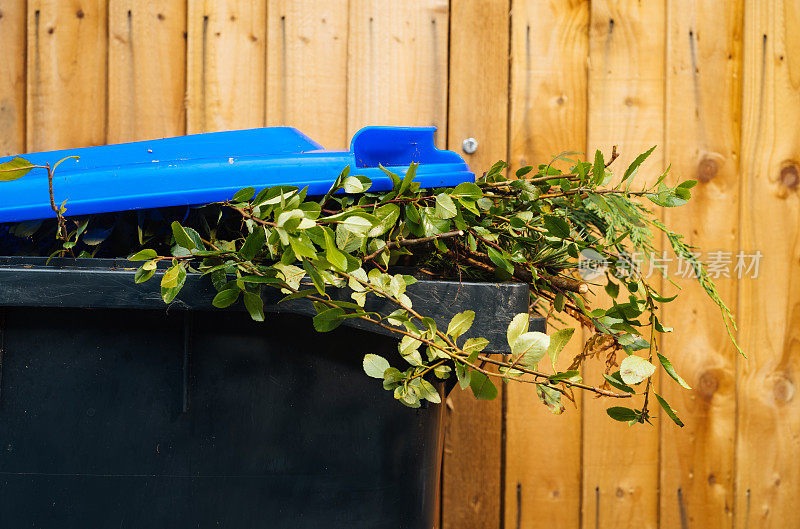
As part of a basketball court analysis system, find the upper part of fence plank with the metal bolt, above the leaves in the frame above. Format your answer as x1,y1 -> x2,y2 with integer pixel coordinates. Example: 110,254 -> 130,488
447,0 -> 509,175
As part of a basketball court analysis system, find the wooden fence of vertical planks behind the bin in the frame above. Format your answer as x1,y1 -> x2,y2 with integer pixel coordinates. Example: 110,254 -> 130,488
0,0 -> 800,529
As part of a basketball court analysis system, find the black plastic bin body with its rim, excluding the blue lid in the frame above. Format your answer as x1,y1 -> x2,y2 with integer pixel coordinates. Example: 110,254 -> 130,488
0,258 -> 528,529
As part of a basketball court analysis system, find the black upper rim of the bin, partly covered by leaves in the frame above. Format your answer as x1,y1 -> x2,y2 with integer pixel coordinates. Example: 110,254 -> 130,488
0,256 -> 545,353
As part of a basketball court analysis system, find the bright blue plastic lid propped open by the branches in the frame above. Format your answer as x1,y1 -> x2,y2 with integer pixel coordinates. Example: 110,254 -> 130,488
0,127 -> 475,222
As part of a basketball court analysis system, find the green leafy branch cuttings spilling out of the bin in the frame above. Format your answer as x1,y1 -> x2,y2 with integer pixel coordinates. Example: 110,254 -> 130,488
0,143 -> 744,425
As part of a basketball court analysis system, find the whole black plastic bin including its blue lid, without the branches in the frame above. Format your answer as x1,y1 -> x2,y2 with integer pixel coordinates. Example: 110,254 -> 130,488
0,127 -> 541,529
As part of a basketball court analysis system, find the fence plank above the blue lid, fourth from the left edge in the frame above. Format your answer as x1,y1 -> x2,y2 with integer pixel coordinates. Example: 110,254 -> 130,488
186,0 -> 267,133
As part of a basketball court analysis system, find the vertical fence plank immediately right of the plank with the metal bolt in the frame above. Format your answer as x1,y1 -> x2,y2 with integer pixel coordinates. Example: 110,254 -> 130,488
505,0 -> 589,529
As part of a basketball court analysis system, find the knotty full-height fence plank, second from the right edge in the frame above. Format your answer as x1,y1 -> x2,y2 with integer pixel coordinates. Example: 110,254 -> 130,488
660,0 -> 742,529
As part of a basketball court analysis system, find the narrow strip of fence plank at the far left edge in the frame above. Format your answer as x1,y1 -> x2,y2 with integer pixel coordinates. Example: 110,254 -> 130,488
0,0 -> 25,156
